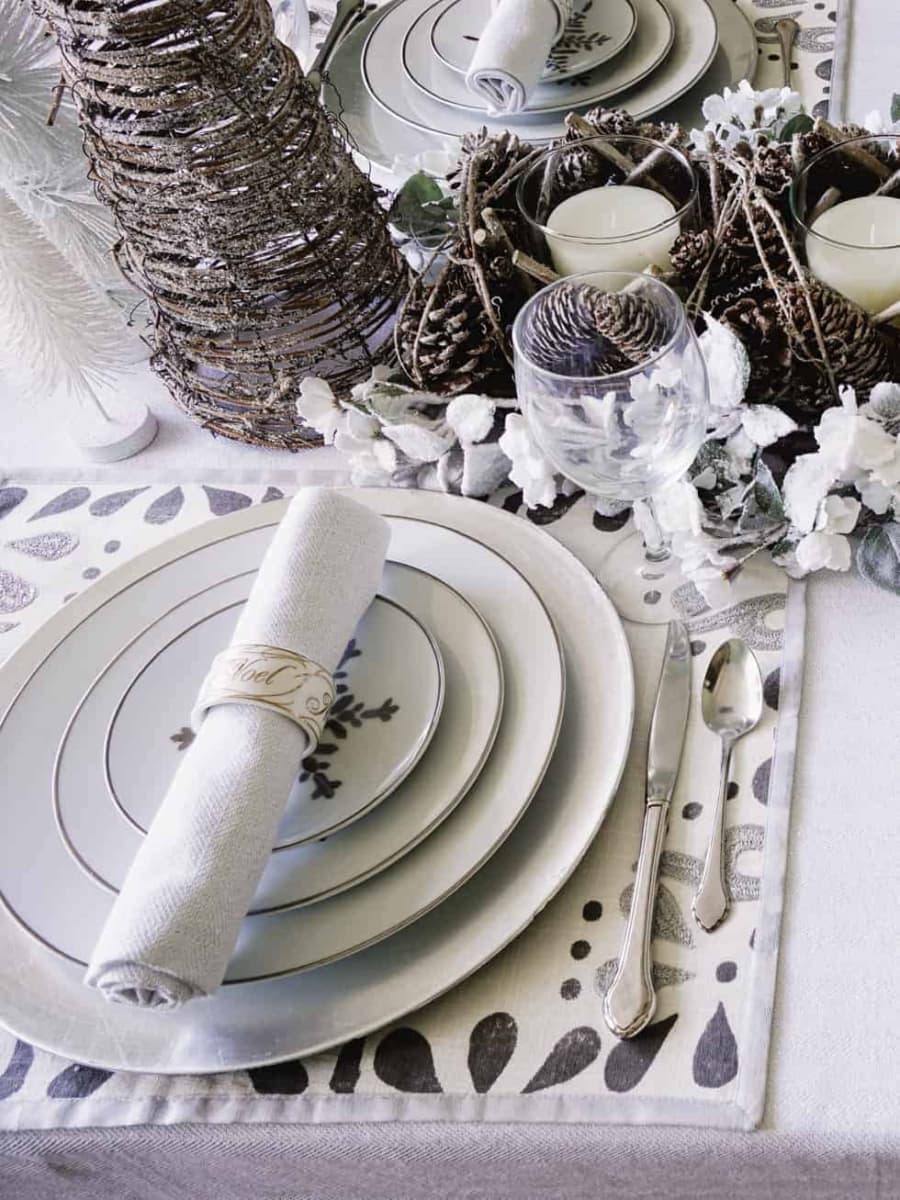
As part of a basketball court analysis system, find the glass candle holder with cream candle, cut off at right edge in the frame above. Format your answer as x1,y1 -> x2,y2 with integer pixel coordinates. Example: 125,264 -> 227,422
791,134 -> 900,316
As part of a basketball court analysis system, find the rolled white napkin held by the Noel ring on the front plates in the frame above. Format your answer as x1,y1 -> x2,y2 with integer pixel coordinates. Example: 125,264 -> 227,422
85,488 -> 390,1008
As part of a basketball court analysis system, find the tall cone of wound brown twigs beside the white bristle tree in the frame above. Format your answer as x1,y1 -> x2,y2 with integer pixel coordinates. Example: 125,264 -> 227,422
35,0 -> 406,449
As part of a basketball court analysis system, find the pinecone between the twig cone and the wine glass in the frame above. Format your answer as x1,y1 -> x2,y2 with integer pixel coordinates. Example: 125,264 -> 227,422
396,264 -> 512,395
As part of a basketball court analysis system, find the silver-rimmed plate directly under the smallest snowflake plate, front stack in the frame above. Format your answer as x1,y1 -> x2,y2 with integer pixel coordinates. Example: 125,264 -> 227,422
53,563 -> 503,913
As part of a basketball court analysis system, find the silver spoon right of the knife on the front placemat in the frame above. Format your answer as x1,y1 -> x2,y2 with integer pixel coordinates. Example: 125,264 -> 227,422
691,637 -> 762,931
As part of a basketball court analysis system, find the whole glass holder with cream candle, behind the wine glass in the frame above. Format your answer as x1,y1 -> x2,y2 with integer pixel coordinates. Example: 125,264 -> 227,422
516,134 -> 697,275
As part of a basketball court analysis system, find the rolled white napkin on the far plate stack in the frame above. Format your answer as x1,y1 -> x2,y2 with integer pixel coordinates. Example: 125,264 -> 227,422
466,0 -> 574,115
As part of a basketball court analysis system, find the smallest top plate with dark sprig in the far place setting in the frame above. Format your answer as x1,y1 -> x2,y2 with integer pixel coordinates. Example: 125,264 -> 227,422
428,0 -> 637,80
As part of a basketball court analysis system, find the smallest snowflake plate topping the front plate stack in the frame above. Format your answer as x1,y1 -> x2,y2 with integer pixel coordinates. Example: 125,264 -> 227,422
106,585 -> 444,849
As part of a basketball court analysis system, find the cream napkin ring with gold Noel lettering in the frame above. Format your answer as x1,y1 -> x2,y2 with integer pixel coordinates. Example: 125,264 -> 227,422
191,642 -> 335,749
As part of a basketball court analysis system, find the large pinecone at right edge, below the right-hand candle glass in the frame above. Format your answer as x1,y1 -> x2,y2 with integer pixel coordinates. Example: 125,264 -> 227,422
770,280 -> 892,420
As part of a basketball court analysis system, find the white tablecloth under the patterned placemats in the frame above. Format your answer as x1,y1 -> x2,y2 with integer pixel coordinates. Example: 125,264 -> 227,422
0,0 -> 900,1200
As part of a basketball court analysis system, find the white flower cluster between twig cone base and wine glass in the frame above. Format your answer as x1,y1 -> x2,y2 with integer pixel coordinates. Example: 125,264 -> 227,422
296,367 -> 514,496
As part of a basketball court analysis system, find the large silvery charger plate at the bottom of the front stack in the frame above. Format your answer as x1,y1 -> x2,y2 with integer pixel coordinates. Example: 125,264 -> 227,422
0,490 -> 634,1074
